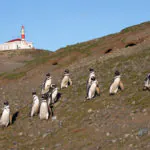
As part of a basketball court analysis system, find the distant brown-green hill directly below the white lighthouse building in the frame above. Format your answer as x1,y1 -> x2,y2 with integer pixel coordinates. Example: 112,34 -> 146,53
0,49 -> 52,79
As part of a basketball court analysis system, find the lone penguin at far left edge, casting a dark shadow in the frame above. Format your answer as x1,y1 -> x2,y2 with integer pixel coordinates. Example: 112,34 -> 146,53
0,101 -> 10,127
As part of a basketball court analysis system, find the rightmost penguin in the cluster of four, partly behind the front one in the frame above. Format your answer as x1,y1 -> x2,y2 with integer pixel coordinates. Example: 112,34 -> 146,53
48,84 -> 58,105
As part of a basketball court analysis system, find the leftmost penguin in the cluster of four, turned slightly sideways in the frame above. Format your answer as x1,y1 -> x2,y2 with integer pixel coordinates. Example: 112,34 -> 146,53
31,92 -> 40,117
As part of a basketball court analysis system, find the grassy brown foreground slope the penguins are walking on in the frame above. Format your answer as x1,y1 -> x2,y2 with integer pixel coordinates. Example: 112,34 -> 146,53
0,22 -> 150,150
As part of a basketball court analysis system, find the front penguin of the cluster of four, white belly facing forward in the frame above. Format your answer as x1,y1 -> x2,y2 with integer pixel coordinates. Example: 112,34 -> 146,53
39,95 -> 49,120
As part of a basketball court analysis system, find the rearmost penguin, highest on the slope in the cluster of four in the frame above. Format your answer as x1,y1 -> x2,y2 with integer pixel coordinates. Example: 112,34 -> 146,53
41,73 -> 52,94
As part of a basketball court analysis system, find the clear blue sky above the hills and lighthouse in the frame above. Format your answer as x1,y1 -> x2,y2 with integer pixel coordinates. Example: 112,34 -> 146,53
0,0 -> 150,51
